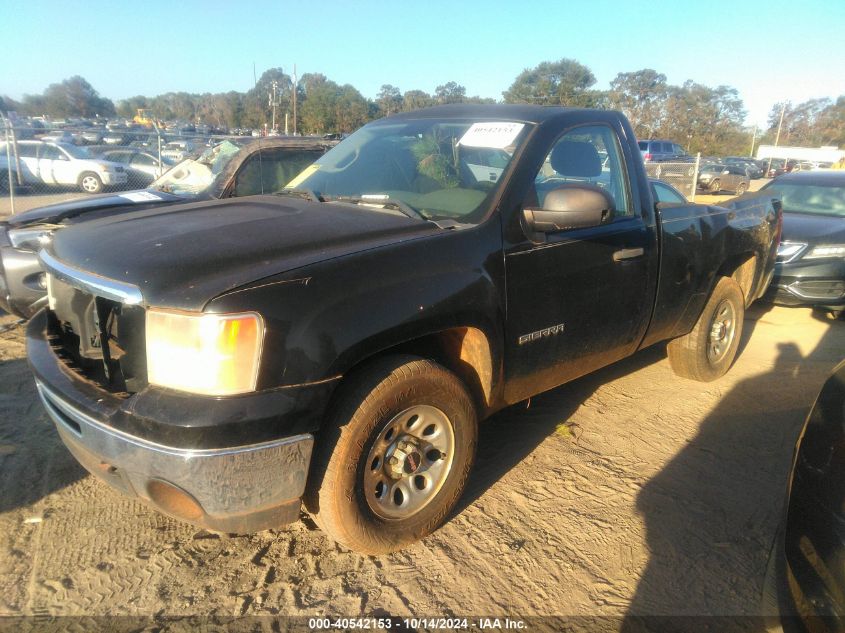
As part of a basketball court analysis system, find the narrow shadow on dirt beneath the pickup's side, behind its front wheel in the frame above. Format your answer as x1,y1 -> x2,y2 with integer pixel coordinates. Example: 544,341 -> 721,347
453,302 -> 772,514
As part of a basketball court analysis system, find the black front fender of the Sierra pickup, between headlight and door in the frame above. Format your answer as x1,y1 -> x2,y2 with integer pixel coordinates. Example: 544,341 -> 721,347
207,216 -> 504,388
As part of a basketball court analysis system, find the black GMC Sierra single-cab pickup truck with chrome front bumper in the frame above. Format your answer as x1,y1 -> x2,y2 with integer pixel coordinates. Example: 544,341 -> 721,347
27,106 -> 781,553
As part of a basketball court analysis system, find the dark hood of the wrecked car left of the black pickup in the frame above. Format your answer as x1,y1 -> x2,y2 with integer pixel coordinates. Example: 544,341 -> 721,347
6,189 -> 186,228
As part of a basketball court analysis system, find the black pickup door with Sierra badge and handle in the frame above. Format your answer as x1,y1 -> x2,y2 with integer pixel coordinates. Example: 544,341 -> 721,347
505,125 -> 657,402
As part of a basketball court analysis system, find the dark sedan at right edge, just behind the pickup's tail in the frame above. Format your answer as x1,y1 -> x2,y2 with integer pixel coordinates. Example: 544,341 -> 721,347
760,171 -> 845,315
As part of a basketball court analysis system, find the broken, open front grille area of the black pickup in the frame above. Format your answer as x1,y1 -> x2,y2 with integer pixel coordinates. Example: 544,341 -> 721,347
48,275 -> 147,395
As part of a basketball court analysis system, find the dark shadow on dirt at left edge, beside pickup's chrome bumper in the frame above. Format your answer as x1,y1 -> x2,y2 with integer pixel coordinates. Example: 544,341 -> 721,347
0,359 -> 87,513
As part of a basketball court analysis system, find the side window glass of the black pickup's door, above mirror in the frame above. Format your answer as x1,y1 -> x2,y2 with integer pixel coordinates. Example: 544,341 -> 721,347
526,125 -> 633,217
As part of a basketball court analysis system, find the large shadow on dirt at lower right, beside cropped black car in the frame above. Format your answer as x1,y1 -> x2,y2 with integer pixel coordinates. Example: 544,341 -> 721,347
622,314 -> 845,620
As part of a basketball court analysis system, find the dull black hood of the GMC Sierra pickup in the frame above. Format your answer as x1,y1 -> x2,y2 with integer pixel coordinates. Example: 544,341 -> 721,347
49,196 -> 443,310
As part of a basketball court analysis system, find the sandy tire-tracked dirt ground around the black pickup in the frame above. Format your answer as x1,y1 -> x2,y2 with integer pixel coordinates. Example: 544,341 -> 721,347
0,306 -> 845,628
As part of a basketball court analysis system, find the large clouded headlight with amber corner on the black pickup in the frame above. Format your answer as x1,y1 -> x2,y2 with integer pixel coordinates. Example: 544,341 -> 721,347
146,310 -> 264,396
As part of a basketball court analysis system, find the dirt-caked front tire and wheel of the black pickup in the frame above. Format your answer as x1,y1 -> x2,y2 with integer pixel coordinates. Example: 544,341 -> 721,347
305,356 -> 478,554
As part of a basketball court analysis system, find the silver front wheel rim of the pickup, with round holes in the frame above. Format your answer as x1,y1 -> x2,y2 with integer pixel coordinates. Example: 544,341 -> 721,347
364,405 -> 455,520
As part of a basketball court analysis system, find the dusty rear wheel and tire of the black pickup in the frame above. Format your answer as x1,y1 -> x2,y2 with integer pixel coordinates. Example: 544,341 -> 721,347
666,277 -> 745,382
